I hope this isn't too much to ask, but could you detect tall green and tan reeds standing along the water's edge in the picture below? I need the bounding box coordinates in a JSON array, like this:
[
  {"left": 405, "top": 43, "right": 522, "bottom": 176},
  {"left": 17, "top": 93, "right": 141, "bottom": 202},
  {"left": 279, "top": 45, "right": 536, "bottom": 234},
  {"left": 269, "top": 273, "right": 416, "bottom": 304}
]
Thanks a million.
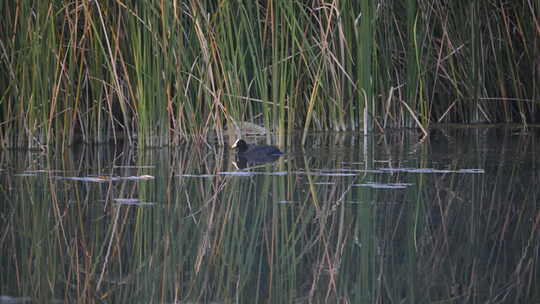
[{"left": 0, "top": 0, "right": 540, "bottom": 148}]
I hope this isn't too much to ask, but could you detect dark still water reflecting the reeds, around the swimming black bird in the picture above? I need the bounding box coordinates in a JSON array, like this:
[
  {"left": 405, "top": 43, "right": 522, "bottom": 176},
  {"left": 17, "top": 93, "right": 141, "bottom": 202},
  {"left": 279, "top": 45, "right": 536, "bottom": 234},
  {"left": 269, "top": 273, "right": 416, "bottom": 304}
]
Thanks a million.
[{"left": 0, "top": 128, "right": 540, "bottom": 303}]
